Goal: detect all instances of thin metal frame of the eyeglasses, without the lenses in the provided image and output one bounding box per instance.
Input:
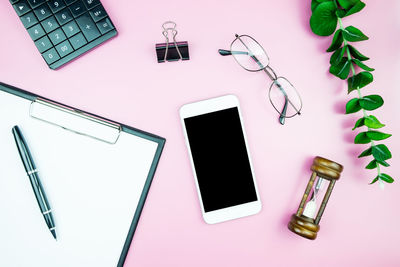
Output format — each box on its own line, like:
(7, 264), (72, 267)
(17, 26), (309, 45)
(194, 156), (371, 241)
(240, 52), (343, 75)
(218, 34), (303, 125)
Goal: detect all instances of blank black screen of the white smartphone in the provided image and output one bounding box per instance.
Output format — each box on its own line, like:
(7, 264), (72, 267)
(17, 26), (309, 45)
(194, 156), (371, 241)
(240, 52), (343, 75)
(184, 107), (257, 212)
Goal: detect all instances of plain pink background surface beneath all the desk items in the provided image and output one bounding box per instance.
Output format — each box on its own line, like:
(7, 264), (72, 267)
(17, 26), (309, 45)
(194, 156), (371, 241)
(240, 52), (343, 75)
(0, 0), (400, 267)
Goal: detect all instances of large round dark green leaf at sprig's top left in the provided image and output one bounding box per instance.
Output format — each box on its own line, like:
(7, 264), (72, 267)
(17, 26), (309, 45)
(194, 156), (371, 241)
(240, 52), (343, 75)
(310, 2), (338, 36)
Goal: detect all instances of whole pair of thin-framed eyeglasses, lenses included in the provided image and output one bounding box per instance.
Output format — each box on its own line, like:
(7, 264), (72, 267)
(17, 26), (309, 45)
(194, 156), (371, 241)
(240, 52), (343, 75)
(218, 34), (303, 125)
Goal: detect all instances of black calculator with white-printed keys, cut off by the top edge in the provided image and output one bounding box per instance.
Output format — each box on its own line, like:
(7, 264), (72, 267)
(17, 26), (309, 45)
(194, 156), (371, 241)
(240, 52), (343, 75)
(10, 0), (117, 69)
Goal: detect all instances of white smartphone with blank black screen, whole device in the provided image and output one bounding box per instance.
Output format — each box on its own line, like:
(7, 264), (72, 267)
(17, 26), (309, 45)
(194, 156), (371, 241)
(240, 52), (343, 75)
(180, 95), (261, 224)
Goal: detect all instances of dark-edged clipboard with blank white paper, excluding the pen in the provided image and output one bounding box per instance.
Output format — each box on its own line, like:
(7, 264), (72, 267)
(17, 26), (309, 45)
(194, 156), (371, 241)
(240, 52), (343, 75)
(0, 82), (165, 267)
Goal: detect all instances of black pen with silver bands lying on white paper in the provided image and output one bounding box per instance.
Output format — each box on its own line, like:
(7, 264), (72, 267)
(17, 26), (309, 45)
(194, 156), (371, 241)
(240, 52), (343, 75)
(12, 126), (57, 240)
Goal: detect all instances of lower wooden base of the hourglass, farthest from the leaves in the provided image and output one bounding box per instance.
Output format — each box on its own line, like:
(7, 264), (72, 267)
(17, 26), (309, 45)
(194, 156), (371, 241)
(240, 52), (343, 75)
(288, 214), (319, 240)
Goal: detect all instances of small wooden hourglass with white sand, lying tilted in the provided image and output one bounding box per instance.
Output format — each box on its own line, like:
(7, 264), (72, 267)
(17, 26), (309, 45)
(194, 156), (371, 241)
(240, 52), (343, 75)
(288, 157), (343, 240)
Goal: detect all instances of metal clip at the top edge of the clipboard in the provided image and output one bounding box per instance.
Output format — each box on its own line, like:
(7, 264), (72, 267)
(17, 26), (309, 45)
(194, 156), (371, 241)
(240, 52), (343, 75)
(29, 97), (122, 144)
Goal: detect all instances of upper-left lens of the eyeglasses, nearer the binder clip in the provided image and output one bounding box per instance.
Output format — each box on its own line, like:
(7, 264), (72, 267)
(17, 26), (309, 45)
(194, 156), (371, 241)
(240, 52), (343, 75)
(231, 35), (269, 71)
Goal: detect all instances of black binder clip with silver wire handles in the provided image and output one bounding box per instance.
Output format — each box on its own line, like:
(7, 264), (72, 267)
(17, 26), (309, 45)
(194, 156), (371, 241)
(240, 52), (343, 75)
(156, 21), (189, 63)
